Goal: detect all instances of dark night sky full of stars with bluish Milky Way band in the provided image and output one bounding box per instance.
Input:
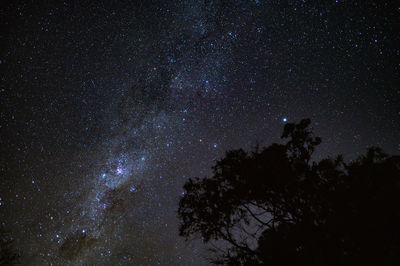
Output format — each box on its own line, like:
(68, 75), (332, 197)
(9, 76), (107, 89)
(0, 0), (400, 265)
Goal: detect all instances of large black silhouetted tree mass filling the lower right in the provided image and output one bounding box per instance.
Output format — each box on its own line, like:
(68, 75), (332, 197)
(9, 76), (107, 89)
(178, 119), (400, 265)
